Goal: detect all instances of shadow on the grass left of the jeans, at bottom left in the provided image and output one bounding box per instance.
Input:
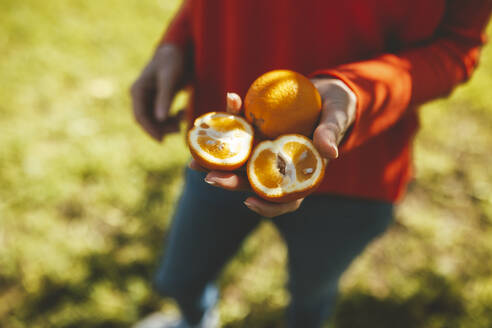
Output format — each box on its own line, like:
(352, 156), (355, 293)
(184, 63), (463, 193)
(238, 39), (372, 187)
(9, 166), (182, 328)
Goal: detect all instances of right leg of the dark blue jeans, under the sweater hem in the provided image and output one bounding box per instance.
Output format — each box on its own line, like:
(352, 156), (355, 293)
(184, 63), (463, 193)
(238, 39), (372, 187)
(273, 195), (393, 328)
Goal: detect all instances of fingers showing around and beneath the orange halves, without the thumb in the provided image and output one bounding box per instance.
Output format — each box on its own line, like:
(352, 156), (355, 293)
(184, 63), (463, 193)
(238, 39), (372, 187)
(190, 93), (303, 218)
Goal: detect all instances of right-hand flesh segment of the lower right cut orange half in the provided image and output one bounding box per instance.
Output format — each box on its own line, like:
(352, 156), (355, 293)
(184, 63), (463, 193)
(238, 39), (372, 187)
(283, 142), (317, 182)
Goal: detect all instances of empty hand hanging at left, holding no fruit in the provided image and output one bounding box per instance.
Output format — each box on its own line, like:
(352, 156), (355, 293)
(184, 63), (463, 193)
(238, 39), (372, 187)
(130, 44), (184, 141)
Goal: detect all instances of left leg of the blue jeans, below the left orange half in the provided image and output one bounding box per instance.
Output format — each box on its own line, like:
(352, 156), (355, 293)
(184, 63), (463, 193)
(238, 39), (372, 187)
(155, 169), (261, 324)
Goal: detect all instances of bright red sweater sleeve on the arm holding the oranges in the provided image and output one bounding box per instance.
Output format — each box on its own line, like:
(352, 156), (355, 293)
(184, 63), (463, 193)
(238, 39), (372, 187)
(313, 0), (492, 151)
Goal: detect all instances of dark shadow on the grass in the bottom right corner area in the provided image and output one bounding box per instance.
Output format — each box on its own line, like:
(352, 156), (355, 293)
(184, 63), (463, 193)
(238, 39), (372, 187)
(334, 271), (466, 328)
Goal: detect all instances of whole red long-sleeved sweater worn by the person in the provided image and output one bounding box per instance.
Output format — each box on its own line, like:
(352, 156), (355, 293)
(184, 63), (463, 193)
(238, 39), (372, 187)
(162, 0), (492, 201)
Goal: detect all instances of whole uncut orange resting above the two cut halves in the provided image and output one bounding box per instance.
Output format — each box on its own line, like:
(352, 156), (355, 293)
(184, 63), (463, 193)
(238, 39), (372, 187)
(244, 70), (321, 139)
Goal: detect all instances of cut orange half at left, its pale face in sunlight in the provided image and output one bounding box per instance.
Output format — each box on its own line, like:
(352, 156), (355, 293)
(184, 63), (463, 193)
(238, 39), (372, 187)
(187, 112), (254, 171)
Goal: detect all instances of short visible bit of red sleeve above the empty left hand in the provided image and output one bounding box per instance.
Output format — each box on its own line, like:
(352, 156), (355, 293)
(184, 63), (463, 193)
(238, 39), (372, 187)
(159, 0), (192, 50)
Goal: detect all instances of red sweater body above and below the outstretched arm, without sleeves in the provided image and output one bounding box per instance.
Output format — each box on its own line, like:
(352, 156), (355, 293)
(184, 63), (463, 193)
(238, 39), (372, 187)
(183, 0), (448, 201)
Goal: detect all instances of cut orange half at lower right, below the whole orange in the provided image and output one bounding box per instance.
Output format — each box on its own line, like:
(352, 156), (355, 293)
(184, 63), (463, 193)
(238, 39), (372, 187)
(247, 134), (325, 203)
